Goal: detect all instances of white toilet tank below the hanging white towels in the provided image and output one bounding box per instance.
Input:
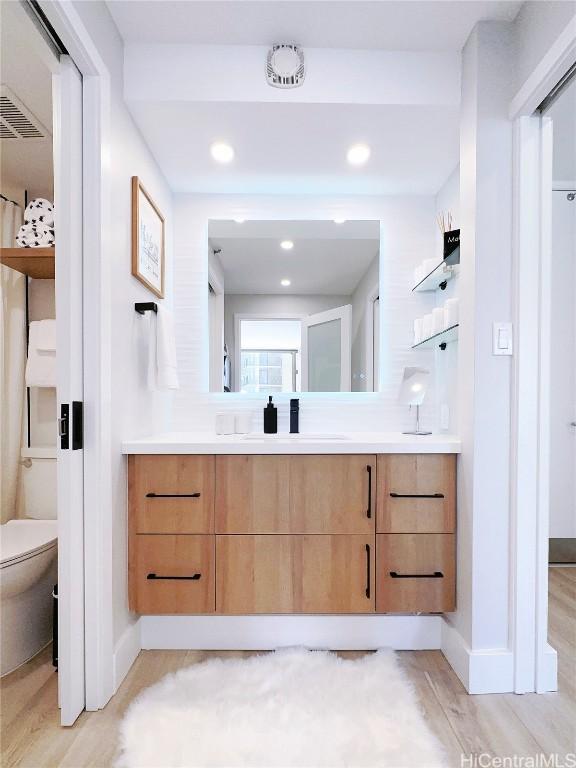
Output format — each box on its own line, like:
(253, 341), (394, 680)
(18, 448), (58, 520)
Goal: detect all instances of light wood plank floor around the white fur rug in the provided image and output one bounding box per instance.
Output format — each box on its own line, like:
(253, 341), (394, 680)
(1, 568), (576, 768)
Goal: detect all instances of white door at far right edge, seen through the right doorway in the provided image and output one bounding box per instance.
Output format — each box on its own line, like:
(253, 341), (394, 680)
(549, 191), (576, 539)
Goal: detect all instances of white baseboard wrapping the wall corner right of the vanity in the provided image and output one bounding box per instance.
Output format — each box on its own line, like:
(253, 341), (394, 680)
(441, 619), (514, 693)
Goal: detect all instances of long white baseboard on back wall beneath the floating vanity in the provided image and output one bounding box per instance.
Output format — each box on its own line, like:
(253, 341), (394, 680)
(140, 615), (442, 651)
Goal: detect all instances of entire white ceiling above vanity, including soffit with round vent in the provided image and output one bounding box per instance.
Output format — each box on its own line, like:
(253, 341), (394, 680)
(108, 0), (522, 195)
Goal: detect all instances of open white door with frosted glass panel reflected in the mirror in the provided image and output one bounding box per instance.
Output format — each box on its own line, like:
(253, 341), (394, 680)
(302, 304), (352, 392)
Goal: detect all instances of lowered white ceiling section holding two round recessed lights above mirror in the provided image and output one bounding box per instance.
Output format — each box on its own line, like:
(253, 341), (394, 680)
(131, 102), (459, 195)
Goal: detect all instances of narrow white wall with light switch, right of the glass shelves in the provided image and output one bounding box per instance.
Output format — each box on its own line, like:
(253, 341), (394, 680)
(445, 22), (514, 690)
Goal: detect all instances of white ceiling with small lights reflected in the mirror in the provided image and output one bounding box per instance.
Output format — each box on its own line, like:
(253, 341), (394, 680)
(209, 221), (380, 296)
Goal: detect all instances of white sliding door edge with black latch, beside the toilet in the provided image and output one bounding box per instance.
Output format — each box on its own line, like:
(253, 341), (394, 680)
(54, 56), (85, 725)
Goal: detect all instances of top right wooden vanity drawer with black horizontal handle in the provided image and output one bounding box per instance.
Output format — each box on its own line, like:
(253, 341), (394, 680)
(376, 454), (456, 533)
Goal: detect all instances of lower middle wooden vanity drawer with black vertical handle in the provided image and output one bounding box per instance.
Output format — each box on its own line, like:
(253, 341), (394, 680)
(216, 535), (375, 614)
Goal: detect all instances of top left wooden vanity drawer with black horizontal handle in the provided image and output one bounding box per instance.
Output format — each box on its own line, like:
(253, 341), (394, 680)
(128, 456), (214, 533)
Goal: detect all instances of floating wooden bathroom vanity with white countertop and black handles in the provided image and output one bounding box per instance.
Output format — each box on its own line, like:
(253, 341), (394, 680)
(124, 435), (459, 615)
